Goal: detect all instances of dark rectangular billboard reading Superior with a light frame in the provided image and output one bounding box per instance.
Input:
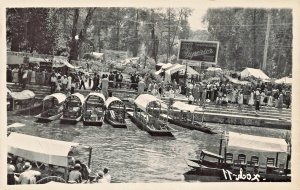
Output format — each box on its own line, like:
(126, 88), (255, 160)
(178, 40), (219, 64)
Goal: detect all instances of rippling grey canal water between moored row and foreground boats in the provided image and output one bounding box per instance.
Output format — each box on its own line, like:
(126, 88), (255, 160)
(7, 112), (287, 183)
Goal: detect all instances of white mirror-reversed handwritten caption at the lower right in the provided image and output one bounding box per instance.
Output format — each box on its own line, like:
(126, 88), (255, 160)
(222, 168), (260, 182)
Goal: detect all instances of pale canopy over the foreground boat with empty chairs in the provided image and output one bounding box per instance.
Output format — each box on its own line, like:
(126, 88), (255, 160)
(228, 132), (288, 152)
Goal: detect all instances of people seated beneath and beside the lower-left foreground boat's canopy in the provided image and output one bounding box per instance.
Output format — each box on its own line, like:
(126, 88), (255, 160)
(7, 155), (111, 185)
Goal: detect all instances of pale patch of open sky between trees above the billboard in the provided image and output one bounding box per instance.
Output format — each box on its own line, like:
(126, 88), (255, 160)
(189, 7), (207, 30)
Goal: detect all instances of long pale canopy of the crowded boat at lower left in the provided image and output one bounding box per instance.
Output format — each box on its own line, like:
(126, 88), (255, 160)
(7, 132), (79, 167)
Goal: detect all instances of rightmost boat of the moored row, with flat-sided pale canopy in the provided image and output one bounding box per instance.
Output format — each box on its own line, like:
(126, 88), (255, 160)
(168, 101), (216, 134)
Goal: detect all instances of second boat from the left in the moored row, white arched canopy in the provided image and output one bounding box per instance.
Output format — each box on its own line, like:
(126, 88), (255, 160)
(34, 93), (67, 122)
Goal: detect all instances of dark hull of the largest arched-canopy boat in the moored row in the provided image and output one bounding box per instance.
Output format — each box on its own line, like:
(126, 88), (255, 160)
(128, 111), (174, 137)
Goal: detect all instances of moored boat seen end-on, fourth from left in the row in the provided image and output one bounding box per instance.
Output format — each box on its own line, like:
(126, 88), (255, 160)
(83, 92), (105, 126)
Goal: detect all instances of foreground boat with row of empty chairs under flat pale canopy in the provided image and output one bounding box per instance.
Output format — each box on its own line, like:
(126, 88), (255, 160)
(183, 132), (291, 182)
